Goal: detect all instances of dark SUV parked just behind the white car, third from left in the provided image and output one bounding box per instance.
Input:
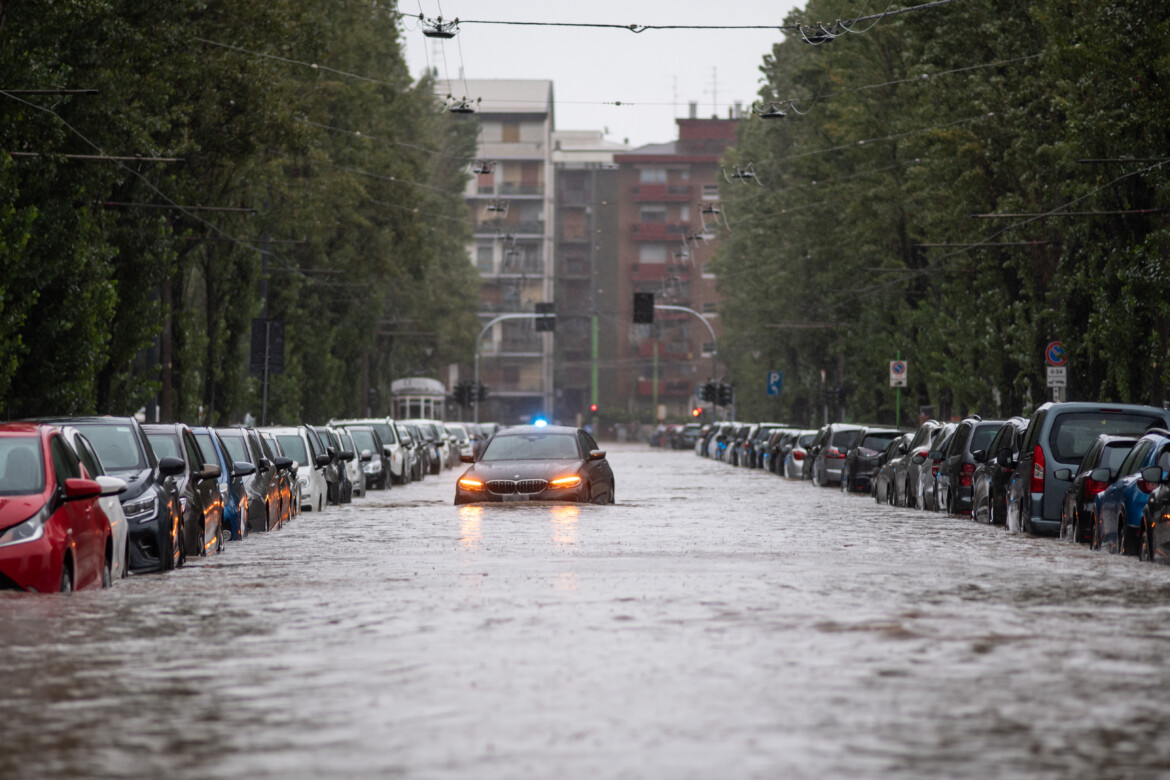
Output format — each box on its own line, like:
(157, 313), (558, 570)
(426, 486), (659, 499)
(49, 416), (186, 574)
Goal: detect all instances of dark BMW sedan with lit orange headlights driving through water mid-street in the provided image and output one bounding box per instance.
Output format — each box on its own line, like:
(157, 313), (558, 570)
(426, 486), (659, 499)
(455, 426), (614, 504)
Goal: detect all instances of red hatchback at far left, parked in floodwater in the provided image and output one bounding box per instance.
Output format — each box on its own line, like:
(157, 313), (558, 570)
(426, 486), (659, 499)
(0, 422), (113, 593)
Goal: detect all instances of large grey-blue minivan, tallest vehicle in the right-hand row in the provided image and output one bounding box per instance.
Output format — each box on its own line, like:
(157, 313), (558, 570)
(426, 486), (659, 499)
(1000, 401), (1170, 534)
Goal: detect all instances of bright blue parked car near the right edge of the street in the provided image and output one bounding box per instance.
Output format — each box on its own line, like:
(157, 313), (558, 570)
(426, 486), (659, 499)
(1089, 429), (1170, 555)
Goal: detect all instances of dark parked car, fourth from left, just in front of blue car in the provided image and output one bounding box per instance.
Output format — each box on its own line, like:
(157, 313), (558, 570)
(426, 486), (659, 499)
(143, 422), (223, 558)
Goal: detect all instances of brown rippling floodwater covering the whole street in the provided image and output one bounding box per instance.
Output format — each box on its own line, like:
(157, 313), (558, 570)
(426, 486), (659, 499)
(0, 446), (1170, 779)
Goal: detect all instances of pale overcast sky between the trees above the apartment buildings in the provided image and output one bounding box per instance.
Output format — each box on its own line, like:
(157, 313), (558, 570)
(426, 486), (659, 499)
(399, 0), (803, 146)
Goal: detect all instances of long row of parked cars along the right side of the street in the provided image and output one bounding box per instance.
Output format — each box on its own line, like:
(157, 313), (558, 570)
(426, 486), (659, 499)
(694, 401), (1170, 561)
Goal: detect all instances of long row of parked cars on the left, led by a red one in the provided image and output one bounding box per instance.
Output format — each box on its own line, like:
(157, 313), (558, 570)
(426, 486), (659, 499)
(0, 416), (494, 593)
